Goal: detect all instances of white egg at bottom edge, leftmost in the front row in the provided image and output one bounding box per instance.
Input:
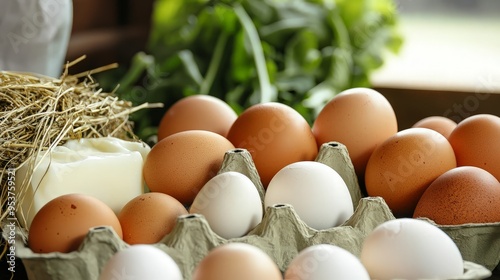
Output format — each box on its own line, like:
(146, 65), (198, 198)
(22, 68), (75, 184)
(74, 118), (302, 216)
(99, 244), (183, 280)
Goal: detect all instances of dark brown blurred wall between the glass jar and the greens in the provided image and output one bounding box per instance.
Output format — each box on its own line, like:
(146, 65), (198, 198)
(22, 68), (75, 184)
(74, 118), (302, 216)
(66, 0), (154, 73)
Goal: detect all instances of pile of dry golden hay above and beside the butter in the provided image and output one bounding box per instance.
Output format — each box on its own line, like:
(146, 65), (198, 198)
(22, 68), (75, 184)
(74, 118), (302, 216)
(0, 63), (162, 256)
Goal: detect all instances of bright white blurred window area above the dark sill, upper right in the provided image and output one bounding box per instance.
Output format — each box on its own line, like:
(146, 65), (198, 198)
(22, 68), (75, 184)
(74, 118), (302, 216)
(373, 0), (500, 92)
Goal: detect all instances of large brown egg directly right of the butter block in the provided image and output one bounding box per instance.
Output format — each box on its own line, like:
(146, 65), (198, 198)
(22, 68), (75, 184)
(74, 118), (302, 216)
(143, 130), (234, 205)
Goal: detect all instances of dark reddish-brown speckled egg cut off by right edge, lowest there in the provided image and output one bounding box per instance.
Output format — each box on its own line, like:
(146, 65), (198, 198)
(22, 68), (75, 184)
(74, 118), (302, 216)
(413, 166), (500, 225)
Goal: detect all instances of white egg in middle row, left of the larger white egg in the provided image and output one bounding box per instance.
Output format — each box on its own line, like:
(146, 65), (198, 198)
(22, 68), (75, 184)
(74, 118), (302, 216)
(189, 171), (263, 239)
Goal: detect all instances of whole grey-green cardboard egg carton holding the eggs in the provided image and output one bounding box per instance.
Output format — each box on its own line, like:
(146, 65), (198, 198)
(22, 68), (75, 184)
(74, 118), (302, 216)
(4, 142), (500, 280)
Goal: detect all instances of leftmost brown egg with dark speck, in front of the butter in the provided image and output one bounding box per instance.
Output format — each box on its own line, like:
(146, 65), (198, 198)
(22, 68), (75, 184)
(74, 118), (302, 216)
(28, 194), (122, 253)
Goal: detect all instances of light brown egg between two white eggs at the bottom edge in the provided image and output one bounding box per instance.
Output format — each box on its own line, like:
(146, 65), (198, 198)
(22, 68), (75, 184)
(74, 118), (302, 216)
(192, 243), (283, 280)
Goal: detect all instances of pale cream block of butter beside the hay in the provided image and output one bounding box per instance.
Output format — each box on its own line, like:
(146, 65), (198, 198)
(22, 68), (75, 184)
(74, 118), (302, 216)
(16, 137), (151, 228)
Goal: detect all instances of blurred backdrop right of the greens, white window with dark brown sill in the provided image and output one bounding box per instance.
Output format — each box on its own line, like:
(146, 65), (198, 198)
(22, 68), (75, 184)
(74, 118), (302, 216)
(372, 0), (500, 130)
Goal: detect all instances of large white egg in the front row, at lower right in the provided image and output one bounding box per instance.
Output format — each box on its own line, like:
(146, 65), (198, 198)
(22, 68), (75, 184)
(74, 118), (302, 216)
(361, 218), (464, 280)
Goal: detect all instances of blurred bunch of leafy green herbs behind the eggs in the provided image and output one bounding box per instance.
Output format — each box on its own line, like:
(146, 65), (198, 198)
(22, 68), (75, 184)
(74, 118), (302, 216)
(97, 0), (402, 138)
